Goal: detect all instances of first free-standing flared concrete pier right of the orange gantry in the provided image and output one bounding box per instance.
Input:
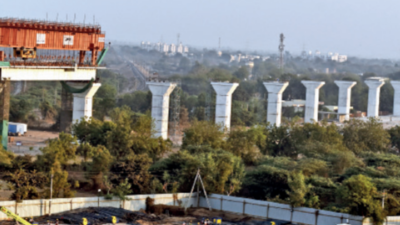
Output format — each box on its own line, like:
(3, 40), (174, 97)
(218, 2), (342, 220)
(146, 82), (176, 139)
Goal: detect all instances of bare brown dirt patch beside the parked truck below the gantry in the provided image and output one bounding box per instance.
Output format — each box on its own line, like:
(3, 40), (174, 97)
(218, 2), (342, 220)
(8, 130), (59, 155)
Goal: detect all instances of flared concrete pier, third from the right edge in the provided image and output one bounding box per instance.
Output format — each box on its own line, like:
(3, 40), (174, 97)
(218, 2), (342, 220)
(335, 80), (357, 120)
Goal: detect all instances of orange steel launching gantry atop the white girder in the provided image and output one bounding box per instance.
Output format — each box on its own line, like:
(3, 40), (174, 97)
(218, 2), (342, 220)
(0, 18), (107, 66)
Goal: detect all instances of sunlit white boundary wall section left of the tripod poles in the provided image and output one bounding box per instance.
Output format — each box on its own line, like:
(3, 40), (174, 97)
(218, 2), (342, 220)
(0, 193), (197, 220)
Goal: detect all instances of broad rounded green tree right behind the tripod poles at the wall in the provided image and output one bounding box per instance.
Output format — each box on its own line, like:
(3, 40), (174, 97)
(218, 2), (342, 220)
(150, 147), (245, 194)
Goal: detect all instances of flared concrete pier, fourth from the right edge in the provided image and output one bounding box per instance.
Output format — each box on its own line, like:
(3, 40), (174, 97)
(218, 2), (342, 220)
(301, 80), (325, 123)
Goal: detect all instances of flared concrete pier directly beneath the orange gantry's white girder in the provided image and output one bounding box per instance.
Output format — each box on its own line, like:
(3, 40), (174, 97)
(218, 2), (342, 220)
(71, 83), (101, 123)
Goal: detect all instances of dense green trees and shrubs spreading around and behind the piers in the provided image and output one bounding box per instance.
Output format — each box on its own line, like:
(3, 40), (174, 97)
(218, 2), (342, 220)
(6, 46), (400, 223)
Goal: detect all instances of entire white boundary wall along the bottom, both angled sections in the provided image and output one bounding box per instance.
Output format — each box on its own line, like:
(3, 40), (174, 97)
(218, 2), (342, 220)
(0, 193), (400, 225)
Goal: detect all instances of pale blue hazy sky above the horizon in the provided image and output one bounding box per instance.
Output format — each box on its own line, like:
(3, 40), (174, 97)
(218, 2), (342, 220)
(0, 0), (400, 58)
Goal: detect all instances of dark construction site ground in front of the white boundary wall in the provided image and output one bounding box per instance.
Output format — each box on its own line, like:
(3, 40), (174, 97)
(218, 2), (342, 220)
(0, 207), (282, 225)
